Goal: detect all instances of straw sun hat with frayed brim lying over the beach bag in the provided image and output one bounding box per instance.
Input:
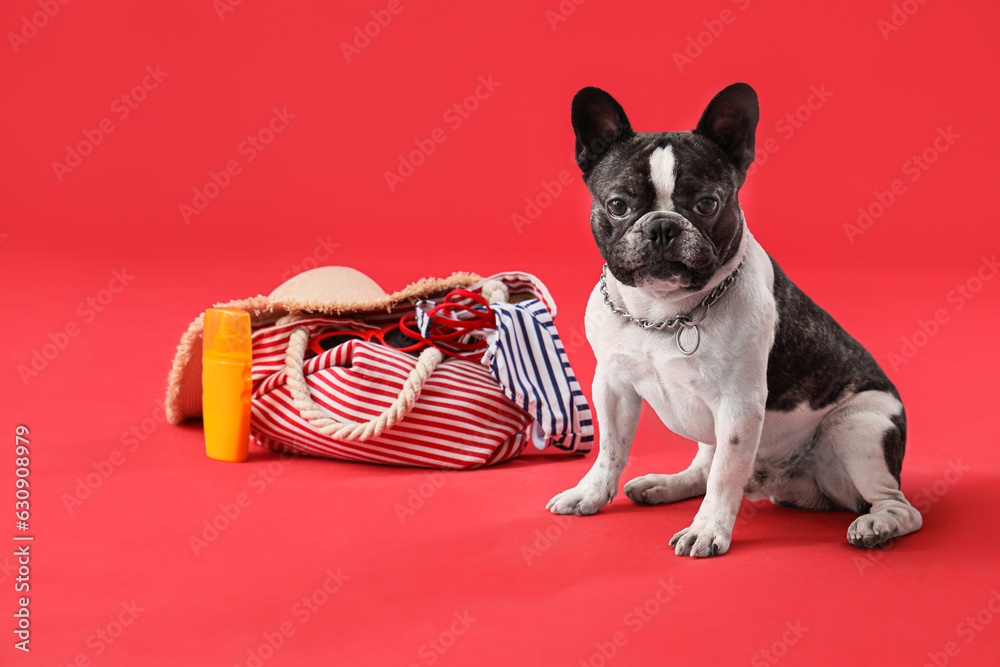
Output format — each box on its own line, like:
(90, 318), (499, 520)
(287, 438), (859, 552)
(166, 266), (482, 424)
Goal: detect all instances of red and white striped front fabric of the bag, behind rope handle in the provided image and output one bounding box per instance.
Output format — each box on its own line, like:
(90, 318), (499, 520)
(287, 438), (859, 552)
(251, 314), (532, 469)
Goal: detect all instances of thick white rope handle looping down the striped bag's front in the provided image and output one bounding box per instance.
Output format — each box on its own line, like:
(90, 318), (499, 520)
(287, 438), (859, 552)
(285, 327), (443, 442)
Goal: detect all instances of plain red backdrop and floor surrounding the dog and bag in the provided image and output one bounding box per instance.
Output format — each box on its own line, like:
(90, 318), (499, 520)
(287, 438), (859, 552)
(0, 0), (1000, 667)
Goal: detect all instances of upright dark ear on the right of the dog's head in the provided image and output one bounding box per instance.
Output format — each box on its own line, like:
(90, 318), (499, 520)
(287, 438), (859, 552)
(695, 83), (760, 174)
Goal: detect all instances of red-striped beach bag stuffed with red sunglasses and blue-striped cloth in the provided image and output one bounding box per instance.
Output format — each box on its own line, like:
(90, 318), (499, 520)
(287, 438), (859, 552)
(160, 267), (593, 469)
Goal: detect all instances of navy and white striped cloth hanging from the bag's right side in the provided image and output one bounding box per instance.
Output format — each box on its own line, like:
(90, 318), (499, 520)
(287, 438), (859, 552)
(416, 299), (594, 453)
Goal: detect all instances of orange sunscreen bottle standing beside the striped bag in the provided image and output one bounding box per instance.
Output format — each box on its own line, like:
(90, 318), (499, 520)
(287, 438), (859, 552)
(201, 308), (251, 462)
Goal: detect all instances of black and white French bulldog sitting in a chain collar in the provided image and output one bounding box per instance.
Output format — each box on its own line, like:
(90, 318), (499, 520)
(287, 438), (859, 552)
(547, 83), (922, 557)
